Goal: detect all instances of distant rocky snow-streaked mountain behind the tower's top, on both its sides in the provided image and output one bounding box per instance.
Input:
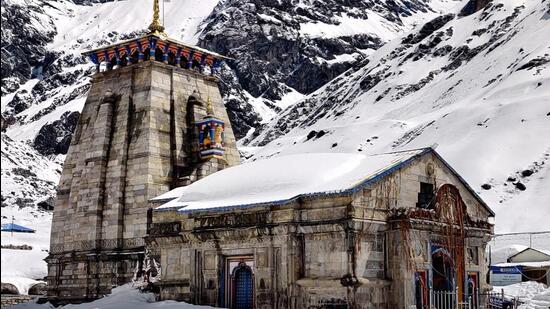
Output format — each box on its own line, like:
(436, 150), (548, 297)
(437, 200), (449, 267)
(2, 0), (466, 148)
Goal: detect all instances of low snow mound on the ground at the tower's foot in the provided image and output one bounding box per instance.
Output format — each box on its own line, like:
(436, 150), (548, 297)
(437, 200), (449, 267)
(10, 284), (213, 309)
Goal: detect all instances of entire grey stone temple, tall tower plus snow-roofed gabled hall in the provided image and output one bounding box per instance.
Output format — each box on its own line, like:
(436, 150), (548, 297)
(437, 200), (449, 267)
(46, 0), (494, 309)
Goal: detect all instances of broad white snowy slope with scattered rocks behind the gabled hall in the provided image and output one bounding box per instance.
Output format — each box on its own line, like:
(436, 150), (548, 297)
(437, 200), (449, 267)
(247, 0), (550, 231)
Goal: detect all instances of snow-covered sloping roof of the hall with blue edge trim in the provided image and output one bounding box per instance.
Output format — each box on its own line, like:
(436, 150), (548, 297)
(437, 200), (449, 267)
(152, 148), (496, 213)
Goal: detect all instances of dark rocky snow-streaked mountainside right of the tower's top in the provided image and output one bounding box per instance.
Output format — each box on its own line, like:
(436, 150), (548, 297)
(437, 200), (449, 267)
(199, 0), (459, 132)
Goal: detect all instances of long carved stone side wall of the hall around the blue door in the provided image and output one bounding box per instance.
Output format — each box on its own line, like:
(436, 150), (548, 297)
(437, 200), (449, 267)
(150, 196), (389, 308)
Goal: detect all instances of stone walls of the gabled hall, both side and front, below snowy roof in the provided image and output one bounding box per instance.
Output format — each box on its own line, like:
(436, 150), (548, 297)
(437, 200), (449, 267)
(148, 154), (491, 308)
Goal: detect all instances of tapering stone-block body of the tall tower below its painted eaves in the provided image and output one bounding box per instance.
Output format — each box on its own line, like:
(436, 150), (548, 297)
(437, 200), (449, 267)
(46, 61), (244, 302)
